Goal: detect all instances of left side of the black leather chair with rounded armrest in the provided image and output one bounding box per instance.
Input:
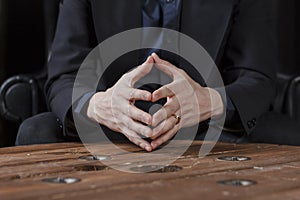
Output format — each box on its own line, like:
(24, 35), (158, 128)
(0, 0), (60, 124)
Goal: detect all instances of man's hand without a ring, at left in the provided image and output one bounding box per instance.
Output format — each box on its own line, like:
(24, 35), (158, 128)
(87, 57), (154, 151)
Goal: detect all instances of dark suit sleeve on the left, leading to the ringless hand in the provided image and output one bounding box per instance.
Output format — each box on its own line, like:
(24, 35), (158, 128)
(45, 0), (97, 136)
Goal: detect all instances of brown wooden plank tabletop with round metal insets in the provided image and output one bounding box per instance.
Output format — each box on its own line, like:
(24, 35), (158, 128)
(0, 142), (300, 200)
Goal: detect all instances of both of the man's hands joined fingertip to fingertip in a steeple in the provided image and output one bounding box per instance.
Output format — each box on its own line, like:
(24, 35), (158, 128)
(87, 54), (224, 151)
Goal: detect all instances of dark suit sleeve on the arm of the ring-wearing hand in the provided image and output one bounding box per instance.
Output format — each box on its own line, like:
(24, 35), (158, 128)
(223, 0), (278, 134)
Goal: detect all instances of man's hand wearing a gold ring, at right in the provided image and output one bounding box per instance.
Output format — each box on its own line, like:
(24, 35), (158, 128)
(151, 54), (224, 149)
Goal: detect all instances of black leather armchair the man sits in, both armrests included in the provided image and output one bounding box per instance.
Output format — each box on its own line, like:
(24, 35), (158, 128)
(0, 0), (300, 143)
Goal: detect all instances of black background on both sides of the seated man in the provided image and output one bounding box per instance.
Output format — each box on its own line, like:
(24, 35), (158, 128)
(0, 0), (300, 147)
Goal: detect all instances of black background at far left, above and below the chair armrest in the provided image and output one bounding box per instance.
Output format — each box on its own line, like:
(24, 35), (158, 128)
(0, 0), (46, 146)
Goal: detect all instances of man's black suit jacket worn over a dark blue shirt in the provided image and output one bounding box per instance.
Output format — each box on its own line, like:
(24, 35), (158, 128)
(46, 0), (278, 133)
